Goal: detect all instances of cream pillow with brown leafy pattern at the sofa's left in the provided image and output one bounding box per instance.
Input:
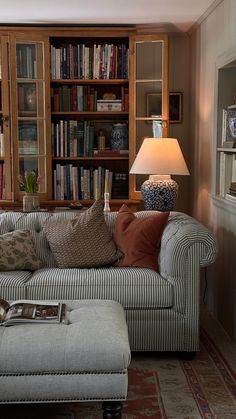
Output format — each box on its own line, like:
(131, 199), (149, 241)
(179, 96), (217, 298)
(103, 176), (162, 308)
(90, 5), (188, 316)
(0, 230), (42, 271)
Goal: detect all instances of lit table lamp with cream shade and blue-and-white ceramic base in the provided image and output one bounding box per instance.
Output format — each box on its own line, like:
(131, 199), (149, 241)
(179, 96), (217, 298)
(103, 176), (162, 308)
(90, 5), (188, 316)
(130, 138), (190, 211)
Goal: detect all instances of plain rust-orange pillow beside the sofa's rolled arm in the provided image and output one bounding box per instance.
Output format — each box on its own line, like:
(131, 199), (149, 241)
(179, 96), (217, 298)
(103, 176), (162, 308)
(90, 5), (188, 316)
(114, 204), (169, 271)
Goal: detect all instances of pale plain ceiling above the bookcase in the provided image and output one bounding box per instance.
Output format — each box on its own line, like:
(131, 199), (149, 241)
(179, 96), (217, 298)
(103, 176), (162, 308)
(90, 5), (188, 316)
(0, 0), (219, 32)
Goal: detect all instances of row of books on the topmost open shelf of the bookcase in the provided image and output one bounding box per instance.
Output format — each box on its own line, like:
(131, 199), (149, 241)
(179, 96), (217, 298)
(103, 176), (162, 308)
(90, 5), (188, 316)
(51, 43), (129, 80)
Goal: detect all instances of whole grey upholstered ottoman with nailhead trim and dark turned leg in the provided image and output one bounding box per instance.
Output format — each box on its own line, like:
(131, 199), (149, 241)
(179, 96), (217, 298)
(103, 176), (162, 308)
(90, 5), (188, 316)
(0, 300), (130, 418)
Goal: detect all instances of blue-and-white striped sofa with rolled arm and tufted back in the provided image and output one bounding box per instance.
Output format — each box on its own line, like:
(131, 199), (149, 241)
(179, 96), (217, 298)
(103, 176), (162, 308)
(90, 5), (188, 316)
(0, 211), (217, 352)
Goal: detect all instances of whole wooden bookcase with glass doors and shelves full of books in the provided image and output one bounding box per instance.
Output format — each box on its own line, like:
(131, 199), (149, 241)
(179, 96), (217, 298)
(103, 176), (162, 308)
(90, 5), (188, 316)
(0, 27), (168, 209)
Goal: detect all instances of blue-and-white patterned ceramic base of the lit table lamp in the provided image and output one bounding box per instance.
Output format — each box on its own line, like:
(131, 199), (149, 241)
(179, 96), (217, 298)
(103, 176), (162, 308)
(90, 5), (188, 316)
(141, 176), (179, 211)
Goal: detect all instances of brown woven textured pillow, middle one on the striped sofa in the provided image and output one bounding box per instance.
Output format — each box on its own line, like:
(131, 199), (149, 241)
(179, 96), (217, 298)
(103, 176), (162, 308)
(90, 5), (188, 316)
(43, 201), (121, 268)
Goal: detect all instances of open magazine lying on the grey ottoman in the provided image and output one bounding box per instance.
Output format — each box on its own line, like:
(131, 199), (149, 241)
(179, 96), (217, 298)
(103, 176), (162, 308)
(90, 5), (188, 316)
(0, 299), (66, 326)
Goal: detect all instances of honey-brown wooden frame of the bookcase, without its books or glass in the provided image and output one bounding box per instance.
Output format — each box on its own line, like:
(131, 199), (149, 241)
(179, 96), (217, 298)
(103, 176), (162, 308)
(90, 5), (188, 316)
(0, 27), (169, 208)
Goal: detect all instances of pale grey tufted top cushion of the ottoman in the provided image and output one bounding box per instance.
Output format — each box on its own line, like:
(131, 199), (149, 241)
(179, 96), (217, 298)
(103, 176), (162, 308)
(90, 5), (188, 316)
(0, 300), (130, 376)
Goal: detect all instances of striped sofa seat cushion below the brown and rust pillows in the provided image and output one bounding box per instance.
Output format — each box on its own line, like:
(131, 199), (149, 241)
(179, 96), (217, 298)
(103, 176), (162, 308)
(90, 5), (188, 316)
(27, 267), (173, 309)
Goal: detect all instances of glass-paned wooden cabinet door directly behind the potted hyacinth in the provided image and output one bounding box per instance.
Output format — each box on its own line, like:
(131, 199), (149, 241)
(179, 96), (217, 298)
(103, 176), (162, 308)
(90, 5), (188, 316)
(9, 37), (50, 199)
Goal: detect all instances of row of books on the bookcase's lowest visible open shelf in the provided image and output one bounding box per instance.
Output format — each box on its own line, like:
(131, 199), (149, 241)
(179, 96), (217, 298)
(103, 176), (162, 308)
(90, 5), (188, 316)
(53, 164), (128, 200)
